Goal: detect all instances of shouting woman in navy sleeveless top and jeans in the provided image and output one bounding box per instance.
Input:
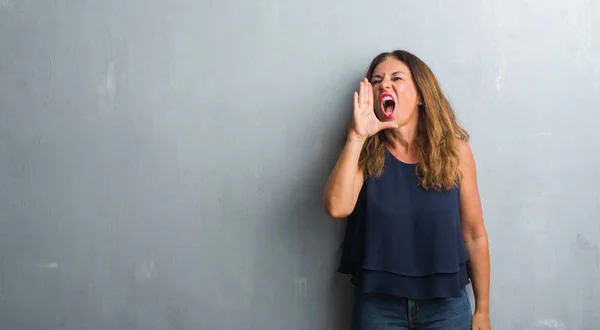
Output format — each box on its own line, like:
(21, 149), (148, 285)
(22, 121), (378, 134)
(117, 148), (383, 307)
(324, 51), (491, 330)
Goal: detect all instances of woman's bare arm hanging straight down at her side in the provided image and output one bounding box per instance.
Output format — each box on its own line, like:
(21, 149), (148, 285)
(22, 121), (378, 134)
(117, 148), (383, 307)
(459, 141), (490, 318)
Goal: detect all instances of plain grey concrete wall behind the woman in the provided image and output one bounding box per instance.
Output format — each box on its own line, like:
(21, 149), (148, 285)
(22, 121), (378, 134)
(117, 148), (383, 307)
(0, 0), (600, 330)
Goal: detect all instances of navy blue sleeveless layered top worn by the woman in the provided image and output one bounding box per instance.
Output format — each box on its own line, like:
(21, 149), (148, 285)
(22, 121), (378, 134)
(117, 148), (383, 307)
(338, 150), (469, 299)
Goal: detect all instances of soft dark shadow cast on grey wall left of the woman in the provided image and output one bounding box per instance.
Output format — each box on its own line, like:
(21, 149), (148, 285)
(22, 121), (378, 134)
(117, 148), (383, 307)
(287, 77), (362, 330)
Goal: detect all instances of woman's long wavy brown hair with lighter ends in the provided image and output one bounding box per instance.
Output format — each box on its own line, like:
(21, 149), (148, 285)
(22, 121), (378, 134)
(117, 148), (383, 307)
(359, 50), (469, 190)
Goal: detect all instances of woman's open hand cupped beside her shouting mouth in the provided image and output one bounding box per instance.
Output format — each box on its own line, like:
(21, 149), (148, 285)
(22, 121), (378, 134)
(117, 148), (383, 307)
(351, 78), (398, 141)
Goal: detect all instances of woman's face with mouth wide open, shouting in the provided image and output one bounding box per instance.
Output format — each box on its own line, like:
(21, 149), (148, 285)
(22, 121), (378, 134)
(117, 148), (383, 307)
(371, 57), (420, 126)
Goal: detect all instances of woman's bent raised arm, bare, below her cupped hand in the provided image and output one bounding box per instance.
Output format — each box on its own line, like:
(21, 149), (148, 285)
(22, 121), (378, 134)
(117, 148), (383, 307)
(323, 133), (364, 219)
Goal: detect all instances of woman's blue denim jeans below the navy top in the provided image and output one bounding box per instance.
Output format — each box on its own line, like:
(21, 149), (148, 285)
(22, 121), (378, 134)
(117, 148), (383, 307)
(351, 288), (472, 330)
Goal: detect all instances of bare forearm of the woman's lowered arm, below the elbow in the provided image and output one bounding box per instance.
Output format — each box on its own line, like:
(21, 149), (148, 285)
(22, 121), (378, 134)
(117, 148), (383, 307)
(466, 235), (490, 313)
